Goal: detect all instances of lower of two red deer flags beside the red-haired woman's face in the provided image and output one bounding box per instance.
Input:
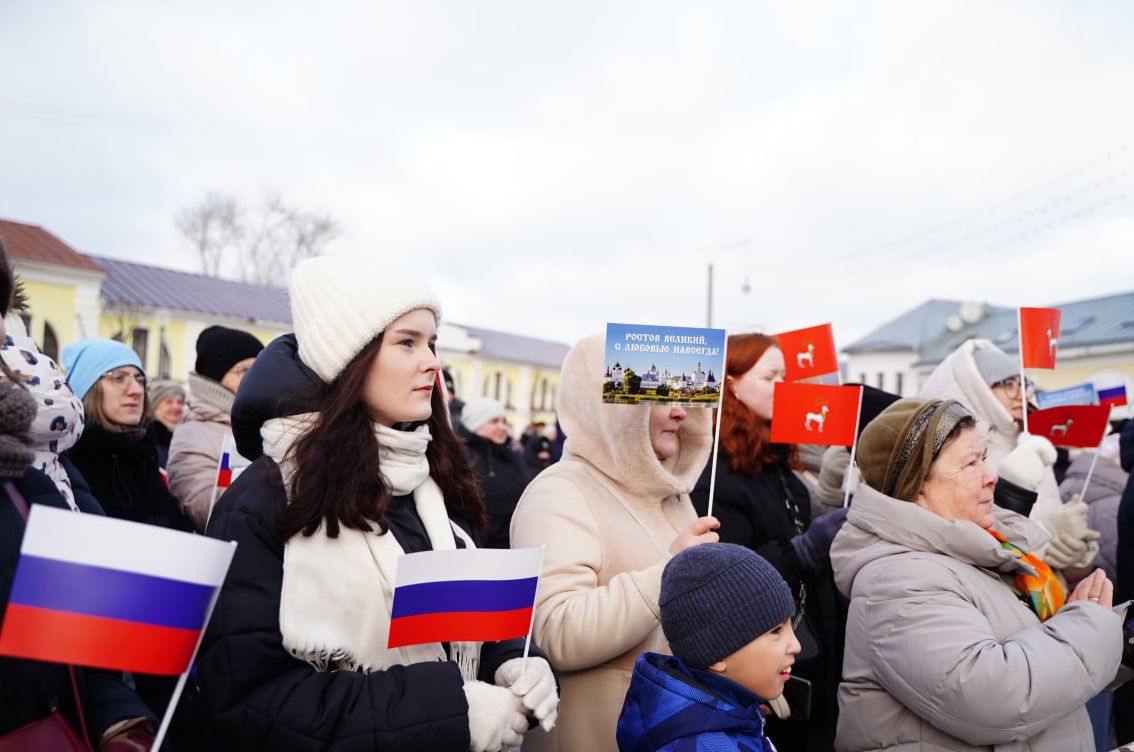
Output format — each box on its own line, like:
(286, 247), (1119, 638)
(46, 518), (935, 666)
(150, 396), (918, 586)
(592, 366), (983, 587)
(772, 381), (862, 447)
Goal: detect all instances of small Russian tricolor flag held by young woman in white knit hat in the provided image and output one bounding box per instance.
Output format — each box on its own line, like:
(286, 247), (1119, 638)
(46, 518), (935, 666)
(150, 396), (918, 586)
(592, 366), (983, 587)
(387, 548), (543, 648)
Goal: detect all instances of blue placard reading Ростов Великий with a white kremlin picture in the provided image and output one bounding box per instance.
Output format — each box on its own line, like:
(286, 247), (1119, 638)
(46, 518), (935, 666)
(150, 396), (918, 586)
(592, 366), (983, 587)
(602, 323), (725, 407)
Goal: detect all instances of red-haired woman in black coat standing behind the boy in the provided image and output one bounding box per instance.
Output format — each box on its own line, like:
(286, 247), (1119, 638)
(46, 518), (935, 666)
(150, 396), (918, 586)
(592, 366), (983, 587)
(693, 335), (846, 751)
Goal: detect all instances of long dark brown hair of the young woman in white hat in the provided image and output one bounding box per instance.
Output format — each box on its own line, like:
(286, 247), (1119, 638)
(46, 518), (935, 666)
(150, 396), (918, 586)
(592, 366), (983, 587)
(280, 335), (488, 540)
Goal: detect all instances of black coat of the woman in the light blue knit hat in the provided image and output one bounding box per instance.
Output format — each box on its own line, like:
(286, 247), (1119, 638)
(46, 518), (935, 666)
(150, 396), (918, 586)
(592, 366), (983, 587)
(66, 423), (192, 532)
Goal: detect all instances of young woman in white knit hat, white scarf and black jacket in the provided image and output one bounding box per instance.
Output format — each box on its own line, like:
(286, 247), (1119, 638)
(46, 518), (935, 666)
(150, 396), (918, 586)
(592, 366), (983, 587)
(197, 256), (558, 752)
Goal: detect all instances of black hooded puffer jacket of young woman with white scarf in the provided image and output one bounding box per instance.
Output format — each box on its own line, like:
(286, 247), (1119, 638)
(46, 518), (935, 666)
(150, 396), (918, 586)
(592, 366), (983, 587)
(197, 336), (542, 752)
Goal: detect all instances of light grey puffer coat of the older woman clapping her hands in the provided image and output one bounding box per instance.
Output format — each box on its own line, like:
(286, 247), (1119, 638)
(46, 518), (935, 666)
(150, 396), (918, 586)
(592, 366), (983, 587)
(831, 485), (1126, 752)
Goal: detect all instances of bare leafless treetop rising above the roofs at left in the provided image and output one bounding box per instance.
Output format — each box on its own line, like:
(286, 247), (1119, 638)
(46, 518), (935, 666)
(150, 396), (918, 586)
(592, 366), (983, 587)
(177, 192), (341, 285)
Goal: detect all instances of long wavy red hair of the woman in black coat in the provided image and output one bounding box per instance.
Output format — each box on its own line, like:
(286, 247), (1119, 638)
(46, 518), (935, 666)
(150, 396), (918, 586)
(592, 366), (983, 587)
(719, 335), (803, 475)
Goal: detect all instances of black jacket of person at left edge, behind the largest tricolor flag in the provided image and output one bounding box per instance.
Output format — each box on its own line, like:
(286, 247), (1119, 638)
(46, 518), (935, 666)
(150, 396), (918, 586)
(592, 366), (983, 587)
(0, 463), (154, 746)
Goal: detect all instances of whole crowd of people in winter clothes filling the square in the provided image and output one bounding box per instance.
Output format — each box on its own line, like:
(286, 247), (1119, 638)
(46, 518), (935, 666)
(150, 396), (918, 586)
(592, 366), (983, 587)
(0, 237), (1134, 752)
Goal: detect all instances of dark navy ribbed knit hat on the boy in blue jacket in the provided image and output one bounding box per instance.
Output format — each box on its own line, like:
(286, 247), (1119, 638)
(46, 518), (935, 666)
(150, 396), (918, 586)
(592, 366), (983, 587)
(658, 543), (795, 668)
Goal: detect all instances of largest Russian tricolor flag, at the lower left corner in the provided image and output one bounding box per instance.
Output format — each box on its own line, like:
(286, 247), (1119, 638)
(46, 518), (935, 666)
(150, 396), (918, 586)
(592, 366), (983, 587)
(0, 505), (236, 675)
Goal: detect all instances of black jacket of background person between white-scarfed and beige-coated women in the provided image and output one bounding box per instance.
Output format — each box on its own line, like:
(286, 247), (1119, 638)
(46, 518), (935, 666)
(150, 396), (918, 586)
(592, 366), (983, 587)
(460, 429), (535, 548)
